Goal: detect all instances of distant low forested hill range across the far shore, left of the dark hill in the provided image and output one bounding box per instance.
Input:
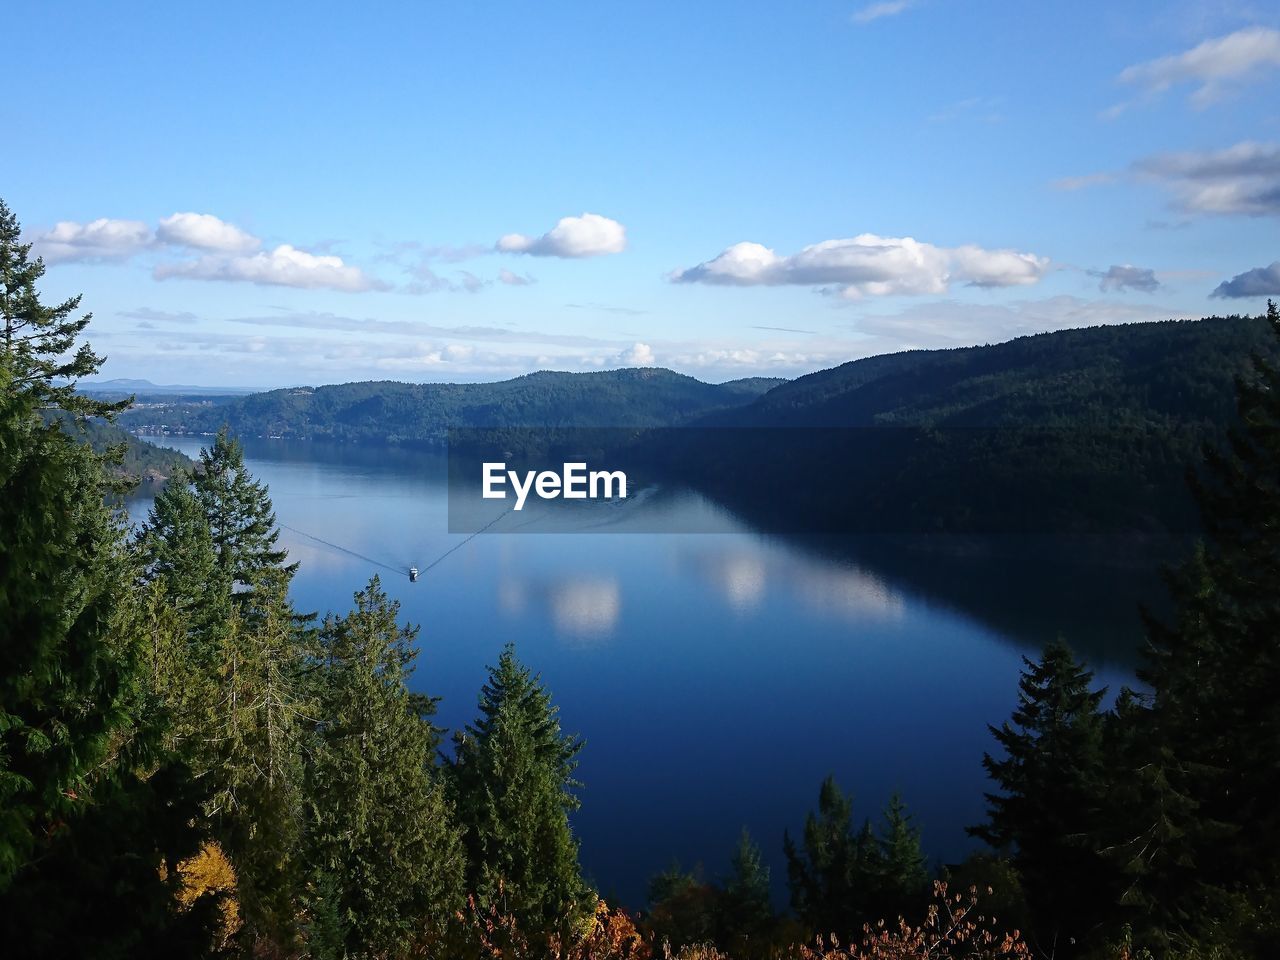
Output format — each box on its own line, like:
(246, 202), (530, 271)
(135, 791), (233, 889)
(120, 367), (783, 444)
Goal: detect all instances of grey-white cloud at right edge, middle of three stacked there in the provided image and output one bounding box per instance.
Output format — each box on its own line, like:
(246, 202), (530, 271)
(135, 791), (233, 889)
(1135, 142), (1280, 216)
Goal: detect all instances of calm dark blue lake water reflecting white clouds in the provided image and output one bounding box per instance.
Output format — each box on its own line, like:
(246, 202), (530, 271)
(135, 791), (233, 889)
(137, 440), (1149, 906)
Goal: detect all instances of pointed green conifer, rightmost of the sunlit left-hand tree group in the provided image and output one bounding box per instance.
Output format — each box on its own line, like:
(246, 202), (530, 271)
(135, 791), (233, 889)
(452, 645), (593, 934)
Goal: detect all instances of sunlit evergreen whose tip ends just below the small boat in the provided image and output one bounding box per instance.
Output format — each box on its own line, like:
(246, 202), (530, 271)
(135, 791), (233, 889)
(305, 577), (463, 956)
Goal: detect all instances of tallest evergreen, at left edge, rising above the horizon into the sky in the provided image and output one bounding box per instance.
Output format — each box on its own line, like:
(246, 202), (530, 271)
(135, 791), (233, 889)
(0, 202), (221, 957)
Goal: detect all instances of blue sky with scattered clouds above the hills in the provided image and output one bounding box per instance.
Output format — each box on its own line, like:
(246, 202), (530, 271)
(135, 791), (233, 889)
(0, 0), (1280, 388)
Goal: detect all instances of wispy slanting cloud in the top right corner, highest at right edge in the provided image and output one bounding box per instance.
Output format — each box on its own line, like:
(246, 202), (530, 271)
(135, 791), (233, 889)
(1108, 27), (1280, 115)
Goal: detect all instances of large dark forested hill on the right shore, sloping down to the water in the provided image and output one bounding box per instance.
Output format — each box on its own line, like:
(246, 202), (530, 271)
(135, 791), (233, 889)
(650, 316), (1277, 534)
